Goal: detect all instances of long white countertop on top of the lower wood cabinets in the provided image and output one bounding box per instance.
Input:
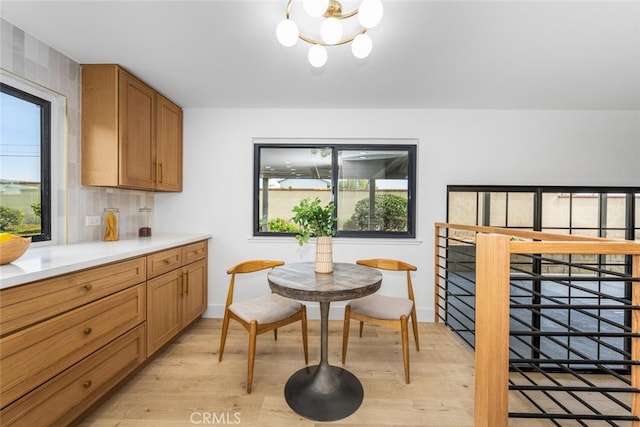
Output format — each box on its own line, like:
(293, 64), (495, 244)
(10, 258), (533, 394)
(0, 234), (211, 289)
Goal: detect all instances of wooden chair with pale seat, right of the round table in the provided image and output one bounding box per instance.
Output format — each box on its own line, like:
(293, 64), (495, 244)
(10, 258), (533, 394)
(342, 258), (420, 384)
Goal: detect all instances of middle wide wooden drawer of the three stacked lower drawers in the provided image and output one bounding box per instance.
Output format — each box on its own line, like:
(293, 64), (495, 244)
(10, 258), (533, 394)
(0, 283), (146, 407)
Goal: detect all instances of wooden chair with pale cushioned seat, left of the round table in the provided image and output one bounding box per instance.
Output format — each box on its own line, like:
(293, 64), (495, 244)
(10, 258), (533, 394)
(218, 260), (309, 393)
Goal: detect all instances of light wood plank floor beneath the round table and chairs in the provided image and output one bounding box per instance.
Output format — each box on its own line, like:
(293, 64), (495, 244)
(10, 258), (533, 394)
(81, 319), (534, 427)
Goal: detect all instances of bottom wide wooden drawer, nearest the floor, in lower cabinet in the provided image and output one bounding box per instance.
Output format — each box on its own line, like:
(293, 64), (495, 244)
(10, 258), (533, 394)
(0, 324), (145, 426)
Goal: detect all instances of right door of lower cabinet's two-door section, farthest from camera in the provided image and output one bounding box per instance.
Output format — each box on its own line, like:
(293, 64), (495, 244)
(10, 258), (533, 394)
(182, 260), (207, 326)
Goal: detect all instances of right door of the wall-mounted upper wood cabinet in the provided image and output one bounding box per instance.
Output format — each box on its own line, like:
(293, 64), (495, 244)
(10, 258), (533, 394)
(156, 95), (182, 191)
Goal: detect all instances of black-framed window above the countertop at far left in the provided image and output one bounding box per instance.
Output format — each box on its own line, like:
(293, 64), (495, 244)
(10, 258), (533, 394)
(0, 83), (51, 241)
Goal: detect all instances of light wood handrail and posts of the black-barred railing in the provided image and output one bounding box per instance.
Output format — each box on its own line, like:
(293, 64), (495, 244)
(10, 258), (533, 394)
(434, 222), (640, 427)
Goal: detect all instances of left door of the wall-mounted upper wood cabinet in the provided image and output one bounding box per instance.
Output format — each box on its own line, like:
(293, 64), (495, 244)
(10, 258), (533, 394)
(119, 70), (157, 189)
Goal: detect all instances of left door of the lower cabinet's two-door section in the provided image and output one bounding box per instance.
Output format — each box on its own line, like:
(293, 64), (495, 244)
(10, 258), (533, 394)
(147, 269), (182, 356)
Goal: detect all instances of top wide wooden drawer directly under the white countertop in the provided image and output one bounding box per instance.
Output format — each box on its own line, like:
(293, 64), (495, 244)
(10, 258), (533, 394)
(0, 257), (146, 335)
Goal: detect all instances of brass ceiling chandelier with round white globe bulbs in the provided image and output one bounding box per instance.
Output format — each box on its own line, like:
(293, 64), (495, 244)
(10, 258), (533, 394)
(276, 0), (383, 67)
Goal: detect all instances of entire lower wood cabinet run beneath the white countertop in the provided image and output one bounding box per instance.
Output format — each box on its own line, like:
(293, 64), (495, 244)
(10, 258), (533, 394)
(0, 240), (208, 426)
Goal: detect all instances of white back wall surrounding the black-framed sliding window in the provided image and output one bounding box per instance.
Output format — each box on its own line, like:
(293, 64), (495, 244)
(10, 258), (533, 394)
(155, 109), (640, 321)
